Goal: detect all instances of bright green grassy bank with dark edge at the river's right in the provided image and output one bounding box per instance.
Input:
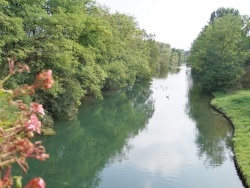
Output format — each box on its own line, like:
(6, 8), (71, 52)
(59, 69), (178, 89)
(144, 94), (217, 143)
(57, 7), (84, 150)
(211, 90), (250, 187)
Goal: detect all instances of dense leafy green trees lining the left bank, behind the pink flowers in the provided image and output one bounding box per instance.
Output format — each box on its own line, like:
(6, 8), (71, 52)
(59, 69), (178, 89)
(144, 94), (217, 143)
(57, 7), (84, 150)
(0, 0), (162, 118)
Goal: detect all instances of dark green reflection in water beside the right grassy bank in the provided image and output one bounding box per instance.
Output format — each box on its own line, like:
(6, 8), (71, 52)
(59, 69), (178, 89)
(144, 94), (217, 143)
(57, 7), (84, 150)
(186, 75), (233, 168)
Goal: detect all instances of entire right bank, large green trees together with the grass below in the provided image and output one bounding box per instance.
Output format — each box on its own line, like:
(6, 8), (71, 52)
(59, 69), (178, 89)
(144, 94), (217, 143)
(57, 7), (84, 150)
(188, 8), (250, 187)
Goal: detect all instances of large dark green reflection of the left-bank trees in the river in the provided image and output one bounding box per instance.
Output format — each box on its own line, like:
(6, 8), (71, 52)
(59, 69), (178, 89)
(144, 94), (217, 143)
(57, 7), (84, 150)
(21, 83), (154, 188)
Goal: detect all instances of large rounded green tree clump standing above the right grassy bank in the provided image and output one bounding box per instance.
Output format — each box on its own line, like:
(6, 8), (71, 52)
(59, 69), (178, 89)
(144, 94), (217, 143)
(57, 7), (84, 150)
(188, 8), (249, 91)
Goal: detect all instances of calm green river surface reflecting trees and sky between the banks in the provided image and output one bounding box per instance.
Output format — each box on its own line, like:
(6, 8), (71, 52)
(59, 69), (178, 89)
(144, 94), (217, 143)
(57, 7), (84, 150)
(25, 66), (243, 188)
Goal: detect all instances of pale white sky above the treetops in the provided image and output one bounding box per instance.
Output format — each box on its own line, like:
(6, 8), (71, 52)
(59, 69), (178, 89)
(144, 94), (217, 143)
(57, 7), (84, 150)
(96, 0), (250, 50)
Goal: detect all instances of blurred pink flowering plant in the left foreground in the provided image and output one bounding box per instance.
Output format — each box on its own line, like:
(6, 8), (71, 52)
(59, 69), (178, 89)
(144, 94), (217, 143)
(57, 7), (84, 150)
(0, 58), (54, 188)
